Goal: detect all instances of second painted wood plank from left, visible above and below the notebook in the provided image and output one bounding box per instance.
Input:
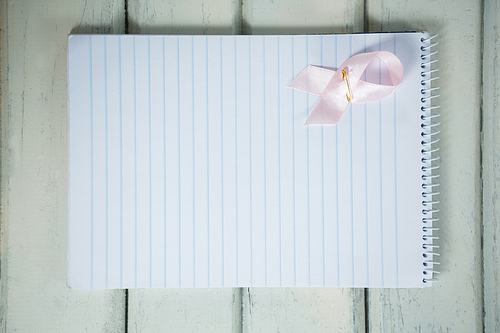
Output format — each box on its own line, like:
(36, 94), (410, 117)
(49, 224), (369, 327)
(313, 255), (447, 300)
(128, 0), (241, 332)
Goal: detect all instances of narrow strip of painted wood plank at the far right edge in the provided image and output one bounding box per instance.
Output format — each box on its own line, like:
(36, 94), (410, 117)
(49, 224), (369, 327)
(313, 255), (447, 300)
(482, 1), (500, 332)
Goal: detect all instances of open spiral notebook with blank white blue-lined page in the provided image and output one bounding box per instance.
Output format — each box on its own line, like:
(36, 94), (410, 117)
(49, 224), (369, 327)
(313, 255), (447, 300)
(68, 32), (439, 289)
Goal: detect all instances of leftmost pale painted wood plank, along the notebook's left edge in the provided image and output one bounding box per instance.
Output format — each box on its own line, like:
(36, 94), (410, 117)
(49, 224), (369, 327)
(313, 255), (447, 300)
(1, 0), (125, 332)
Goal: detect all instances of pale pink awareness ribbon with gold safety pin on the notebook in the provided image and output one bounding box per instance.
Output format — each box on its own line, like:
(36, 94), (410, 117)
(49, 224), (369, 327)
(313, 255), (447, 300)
(290, 51), (404, 125)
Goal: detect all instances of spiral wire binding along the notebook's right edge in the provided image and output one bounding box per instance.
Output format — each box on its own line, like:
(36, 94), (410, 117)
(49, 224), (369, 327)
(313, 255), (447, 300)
(420, 33), (441, 283)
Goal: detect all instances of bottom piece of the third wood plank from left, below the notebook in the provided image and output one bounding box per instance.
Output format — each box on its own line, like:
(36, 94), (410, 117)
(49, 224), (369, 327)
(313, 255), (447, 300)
(242, 288), (365, 333)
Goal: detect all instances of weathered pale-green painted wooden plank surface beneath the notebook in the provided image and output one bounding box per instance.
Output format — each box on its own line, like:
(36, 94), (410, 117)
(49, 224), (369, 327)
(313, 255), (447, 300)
(0, 0), (500, 332)
